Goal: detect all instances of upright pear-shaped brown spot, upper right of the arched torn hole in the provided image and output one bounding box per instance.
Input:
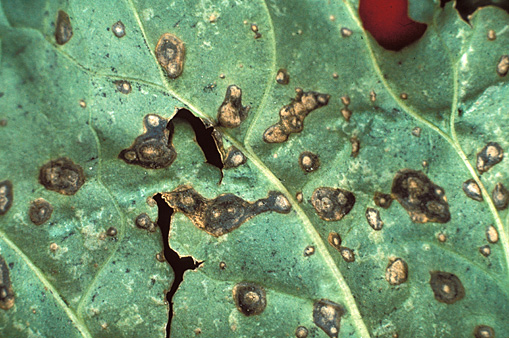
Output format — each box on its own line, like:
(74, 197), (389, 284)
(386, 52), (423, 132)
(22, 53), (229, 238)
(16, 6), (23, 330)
(217, 85), (250, 128)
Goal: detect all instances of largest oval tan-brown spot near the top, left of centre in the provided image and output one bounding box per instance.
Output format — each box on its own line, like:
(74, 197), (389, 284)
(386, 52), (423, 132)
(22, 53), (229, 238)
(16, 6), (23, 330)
(155, 33), (186, 79)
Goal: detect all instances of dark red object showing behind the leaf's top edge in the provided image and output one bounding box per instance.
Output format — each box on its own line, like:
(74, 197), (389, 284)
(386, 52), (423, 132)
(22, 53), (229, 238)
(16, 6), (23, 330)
(359, 0), (428, 51)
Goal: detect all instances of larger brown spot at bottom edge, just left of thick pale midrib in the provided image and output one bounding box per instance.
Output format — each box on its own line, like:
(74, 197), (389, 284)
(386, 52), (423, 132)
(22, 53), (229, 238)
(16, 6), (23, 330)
(313, 299), (345, 338)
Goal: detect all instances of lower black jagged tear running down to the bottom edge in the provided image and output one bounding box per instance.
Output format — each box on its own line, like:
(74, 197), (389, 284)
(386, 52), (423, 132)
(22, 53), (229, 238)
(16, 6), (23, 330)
(153, 194), (203, 337)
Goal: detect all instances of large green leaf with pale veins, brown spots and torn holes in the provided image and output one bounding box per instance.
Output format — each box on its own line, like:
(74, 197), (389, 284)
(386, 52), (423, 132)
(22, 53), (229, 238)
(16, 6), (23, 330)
(0, 0), (509, 338)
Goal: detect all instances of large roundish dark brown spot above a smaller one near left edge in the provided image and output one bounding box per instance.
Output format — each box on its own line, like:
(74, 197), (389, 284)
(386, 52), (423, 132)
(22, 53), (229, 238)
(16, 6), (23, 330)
(39, 157), (85, 195)
